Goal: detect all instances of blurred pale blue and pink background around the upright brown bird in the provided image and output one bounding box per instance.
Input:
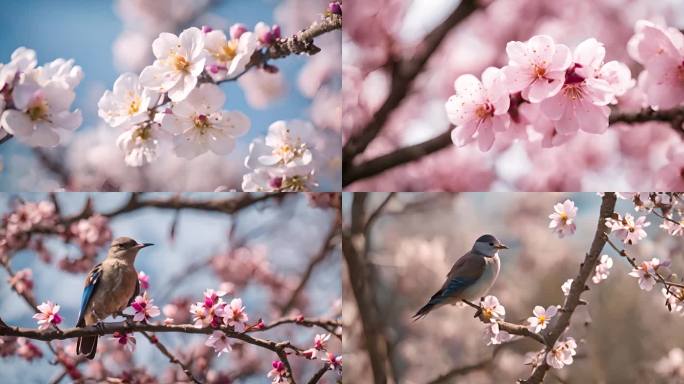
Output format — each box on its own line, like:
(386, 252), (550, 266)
(0, 193), (341, 383)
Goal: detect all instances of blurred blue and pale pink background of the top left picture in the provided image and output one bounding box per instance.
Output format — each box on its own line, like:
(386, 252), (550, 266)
(0, 0), (341, 191)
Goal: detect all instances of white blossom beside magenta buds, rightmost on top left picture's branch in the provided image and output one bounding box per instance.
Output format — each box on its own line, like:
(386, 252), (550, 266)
(204, 24), (257, 81)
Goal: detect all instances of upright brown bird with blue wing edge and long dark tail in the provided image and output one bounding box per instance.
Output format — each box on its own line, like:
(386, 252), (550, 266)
(76, 237), (153, 360)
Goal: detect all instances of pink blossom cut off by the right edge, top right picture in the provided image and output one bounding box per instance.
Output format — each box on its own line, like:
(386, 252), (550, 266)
(627, 20), (684, 109)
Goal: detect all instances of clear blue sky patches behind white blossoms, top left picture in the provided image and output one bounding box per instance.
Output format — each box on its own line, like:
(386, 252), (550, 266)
(0, 0), (329, 191)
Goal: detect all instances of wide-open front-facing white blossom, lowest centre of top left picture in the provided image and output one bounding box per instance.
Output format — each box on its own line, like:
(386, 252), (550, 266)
(162, 83), (250, 159)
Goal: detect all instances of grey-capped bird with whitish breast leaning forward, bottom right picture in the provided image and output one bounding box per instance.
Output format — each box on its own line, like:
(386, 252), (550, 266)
(413, 235), (508, 320)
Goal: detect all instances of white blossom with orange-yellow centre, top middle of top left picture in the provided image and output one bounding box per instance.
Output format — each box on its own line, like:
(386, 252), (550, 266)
(140, 27), (206, 102)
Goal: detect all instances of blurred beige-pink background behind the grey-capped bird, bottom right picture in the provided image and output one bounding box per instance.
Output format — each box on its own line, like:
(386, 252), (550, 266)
(343, 193), (684, 384)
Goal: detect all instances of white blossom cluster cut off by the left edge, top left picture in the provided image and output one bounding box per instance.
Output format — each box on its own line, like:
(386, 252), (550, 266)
(0, 47), (83, 147)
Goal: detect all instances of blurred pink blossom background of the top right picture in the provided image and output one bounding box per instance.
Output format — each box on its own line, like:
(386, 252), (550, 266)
(342, 0), (684, 192)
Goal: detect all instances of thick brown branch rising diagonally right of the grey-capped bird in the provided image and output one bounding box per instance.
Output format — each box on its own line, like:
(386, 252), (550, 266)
(519, 192), (617, 384)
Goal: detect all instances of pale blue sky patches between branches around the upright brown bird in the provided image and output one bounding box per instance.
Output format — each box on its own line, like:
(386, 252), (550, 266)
(0, 193), (342, 384)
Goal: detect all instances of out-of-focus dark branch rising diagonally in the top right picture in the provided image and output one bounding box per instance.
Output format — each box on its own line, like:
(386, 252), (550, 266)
(342, 0), (478, 169)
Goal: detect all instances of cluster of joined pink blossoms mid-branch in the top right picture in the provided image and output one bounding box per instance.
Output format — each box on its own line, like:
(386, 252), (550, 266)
(445, 35), (634, 151)
